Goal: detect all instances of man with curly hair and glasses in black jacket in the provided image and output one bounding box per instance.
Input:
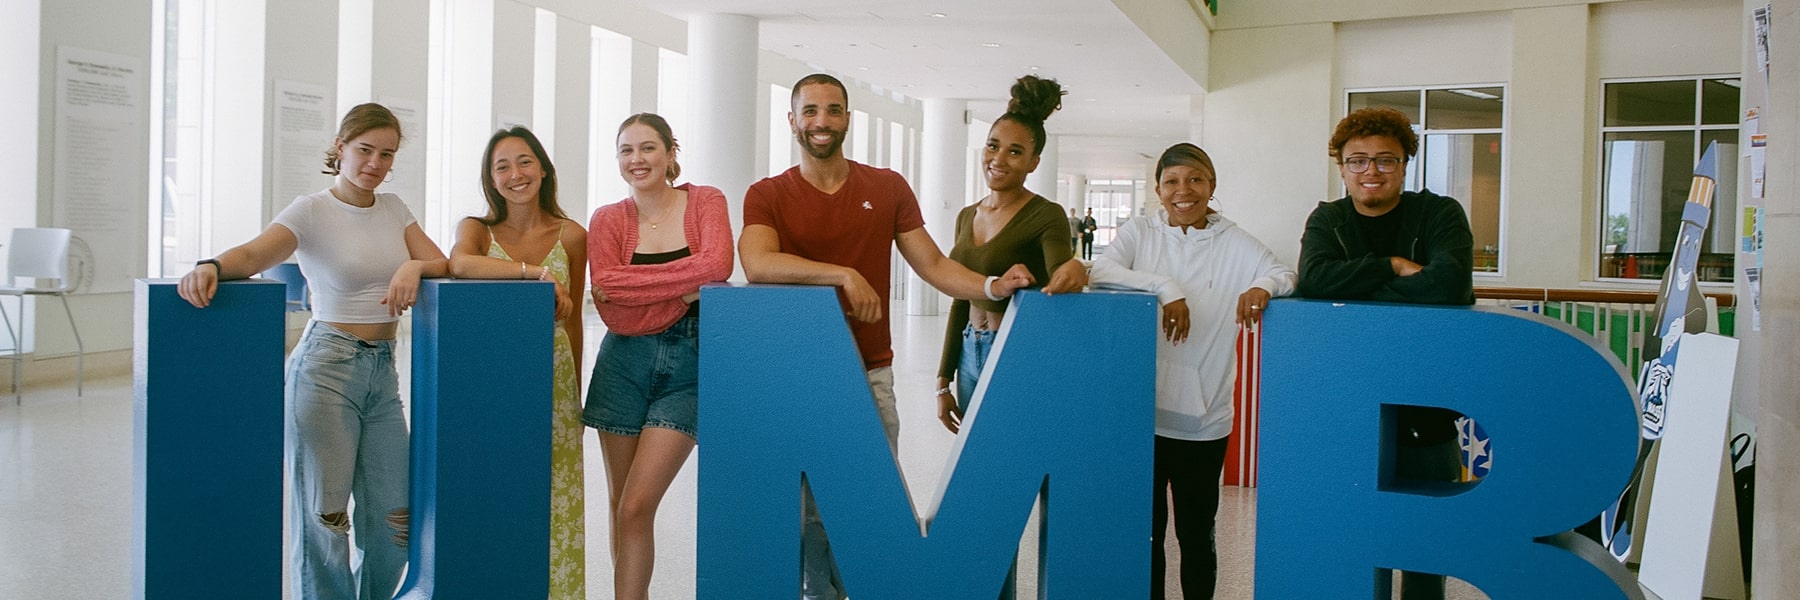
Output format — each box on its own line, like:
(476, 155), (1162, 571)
(1300, 108), (1474, 600)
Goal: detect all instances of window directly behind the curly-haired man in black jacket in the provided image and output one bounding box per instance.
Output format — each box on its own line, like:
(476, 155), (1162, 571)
(1350, 86), (1507, 274)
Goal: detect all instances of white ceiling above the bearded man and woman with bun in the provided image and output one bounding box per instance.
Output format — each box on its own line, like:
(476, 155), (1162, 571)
(639, 0), (1201, 178)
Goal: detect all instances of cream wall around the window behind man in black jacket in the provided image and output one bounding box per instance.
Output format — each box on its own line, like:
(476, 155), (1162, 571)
(1202, 0), (1742, 288)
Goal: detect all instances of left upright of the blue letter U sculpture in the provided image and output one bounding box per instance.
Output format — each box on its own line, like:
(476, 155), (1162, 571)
(131, 279), (284, 600)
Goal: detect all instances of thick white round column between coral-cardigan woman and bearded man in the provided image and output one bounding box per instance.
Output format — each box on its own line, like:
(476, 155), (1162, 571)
(675, 14), (760, 234)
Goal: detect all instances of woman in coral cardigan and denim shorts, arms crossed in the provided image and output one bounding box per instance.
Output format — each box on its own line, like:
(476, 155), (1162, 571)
(581, 114), (733, 600)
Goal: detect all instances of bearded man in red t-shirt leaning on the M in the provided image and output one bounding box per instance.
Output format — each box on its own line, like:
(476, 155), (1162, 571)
(738, 74), (1031, 600)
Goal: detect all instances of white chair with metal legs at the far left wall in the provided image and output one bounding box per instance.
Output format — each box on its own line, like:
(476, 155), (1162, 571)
(0, 227), (86, 404)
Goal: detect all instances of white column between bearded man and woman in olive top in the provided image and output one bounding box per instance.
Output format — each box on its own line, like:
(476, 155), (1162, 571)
(905, 99), (968, 315)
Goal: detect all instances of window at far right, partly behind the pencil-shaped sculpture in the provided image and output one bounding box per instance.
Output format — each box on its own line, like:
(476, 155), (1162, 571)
(1598, 77), (1739, 283)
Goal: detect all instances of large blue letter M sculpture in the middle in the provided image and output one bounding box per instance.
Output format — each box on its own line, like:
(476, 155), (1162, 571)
(698, 286), (1156, 600)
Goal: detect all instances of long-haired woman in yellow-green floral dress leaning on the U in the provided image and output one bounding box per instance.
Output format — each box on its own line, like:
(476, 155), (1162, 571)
(450, 126), (587, 600)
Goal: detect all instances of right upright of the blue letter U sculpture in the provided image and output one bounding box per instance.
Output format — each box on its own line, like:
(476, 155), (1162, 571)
(400, 279), (554, 600)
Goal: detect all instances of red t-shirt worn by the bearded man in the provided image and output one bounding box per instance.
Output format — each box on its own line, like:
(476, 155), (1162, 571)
(743, 160), (925, 369)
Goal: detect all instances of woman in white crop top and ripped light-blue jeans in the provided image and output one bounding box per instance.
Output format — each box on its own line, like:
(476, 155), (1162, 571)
(180, 103), (450, 600)
